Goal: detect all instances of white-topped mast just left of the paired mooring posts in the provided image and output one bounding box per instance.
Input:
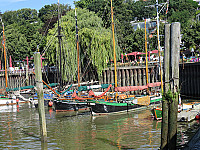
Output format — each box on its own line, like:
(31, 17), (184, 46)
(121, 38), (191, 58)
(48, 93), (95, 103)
(156, 0), (163, 92)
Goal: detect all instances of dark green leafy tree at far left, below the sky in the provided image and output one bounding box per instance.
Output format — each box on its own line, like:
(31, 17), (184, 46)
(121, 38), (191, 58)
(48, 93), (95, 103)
(3, 9), (45, 60)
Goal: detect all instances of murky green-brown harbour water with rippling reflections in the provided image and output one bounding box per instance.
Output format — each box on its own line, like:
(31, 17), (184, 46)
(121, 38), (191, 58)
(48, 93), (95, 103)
(0, 104), (198, 150)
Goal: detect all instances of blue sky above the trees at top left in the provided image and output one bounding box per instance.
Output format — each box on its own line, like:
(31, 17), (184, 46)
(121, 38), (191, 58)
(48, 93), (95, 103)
(0, 0), (78, 13)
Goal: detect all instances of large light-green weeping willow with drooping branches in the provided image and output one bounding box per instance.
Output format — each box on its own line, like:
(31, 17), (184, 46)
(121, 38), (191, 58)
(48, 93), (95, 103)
(46, 8), (120, 81)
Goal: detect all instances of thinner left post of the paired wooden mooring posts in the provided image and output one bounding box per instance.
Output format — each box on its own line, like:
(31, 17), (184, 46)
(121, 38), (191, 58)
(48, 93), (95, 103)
(160, 24), (170, 150)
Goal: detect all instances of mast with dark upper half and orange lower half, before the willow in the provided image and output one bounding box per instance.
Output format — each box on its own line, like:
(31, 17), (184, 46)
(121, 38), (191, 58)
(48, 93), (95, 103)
(75, 8), (80, 87)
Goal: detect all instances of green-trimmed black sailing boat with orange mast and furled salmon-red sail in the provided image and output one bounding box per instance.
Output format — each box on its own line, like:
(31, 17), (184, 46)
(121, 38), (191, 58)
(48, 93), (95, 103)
(90, 0), (162, 115)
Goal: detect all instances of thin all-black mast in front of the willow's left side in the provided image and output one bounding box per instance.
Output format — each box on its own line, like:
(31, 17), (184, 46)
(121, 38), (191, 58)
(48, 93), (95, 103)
(57, 0), (63, 91)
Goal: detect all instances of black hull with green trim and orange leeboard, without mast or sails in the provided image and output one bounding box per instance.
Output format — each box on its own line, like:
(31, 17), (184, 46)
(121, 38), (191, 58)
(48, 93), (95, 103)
(90, 96), (162, 115)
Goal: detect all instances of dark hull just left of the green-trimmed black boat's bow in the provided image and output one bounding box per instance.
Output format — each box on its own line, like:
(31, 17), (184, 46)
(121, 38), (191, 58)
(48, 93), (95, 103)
(53, 100), (89, 112)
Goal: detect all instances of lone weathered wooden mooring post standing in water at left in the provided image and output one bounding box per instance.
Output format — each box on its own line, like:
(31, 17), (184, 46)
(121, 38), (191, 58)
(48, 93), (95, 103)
(34, 52), (47, 142)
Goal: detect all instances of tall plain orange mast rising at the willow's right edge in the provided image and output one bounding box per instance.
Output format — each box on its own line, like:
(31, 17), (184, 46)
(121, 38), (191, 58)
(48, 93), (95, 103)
(111, 0), (117, 90)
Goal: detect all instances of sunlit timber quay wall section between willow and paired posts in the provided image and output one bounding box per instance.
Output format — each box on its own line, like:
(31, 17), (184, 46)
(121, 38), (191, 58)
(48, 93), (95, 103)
(101, 66), (160, 86)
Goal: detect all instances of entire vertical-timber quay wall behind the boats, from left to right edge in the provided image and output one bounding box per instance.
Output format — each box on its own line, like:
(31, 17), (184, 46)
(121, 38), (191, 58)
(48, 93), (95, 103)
(0, 62), (200, 99)
